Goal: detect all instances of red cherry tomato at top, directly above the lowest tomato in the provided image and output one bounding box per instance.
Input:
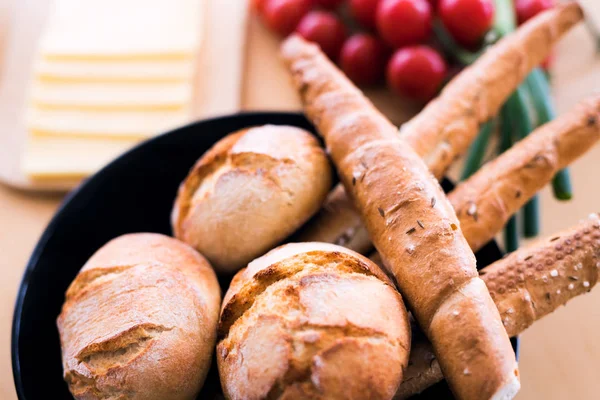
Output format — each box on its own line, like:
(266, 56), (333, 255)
(376, 0), (431, 48)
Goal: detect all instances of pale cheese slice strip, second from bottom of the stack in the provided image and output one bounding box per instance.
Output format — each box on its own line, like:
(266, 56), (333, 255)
(27, 107), (190, 138)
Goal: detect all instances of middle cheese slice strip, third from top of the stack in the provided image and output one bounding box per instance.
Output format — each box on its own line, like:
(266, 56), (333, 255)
(31, 81), (192, 110)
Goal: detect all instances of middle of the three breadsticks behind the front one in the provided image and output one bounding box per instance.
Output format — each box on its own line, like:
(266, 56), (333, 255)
(448, 96), (600, 251)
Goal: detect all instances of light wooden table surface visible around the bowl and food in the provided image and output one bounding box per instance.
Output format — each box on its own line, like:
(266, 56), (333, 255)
(0, 0), (600, 400)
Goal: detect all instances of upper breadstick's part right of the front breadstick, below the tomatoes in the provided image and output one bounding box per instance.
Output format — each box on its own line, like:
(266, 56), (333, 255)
(400, 2), (583, 178)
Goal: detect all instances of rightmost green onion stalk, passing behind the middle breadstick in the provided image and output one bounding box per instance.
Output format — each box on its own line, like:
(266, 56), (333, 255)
(526, 68), (573, 200)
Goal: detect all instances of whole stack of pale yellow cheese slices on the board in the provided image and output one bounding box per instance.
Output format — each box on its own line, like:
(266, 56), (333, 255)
(23, 0), (204, 180)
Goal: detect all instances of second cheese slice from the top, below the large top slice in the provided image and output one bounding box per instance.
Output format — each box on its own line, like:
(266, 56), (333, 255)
(34, 59), (194, 82)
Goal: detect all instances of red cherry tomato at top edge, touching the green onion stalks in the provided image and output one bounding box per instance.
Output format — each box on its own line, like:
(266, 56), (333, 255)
(438, 0), (494, 48)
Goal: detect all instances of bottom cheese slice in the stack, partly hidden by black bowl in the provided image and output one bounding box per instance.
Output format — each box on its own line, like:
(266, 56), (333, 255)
(23, 137), (138, 180)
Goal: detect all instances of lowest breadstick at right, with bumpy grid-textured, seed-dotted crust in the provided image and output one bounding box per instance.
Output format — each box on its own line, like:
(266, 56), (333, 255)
(395, 214), (600, 399)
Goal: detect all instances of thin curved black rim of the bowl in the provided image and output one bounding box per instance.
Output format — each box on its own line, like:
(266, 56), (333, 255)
(10, 110), (521, 399)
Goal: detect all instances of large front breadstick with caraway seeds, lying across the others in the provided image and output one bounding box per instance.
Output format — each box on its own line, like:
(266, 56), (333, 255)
(282, 36), (520, 399)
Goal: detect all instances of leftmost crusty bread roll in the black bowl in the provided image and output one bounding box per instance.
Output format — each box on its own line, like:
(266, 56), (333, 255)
(57, 233), (221, 400)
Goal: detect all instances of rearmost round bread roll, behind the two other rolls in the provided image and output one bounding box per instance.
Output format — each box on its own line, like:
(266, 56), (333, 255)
(172, 125), (332, 273)
